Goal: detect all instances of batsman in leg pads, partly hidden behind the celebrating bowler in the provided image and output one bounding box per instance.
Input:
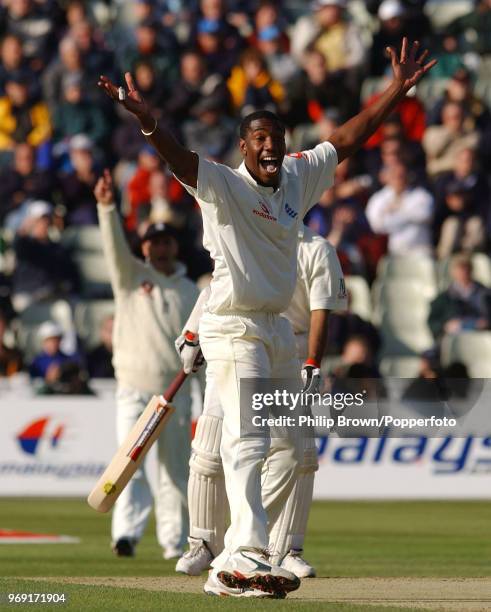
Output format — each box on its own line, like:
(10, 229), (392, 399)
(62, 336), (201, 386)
(176, 227), (347, 578)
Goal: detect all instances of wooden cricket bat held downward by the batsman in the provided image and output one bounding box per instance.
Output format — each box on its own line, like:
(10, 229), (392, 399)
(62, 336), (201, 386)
(87, 370), (187, 512)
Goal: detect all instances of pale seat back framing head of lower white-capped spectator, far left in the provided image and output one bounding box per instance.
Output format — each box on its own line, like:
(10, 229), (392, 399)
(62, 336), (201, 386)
(16, 300), (76, 363)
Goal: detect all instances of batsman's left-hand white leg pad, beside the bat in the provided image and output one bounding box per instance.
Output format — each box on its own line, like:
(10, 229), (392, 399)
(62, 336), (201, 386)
(188, 414), (228, 556)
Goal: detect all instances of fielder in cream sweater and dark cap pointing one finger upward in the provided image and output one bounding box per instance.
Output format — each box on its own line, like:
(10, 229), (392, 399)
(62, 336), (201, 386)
(94, 170), (199, 559)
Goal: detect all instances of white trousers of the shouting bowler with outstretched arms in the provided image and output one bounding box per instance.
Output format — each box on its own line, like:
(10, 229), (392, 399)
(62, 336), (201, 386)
(199, 313), (302, 566)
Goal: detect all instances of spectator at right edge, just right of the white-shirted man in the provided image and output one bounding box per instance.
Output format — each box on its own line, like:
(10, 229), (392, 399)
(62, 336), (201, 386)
(437, 181), (486, 259)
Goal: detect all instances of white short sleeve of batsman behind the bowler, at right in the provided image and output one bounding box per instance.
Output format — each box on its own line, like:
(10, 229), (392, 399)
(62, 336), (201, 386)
(309, 244), (348, 311)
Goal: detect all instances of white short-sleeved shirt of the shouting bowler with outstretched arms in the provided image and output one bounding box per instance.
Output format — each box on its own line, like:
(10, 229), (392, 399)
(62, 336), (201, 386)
(183, 142), (338, 314)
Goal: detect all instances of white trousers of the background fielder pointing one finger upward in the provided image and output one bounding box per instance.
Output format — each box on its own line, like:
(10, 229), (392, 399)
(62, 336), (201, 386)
(112, 388), (191, 551)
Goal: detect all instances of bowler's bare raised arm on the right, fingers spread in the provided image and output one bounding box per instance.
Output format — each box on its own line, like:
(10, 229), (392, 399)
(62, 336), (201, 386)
(329, 38), (437, 163)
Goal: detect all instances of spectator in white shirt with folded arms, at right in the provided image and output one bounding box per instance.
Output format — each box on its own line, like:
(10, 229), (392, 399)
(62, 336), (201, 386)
(366, 163), (434, 255)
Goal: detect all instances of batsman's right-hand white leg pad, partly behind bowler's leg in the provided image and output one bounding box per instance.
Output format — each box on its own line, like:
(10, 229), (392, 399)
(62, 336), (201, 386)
(269, 438), (319, 563)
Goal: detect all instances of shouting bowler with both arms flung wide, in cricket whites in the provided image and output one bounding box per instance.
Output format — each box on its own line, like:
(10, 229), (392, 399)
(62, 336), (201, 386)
(99, 38), (436, 597)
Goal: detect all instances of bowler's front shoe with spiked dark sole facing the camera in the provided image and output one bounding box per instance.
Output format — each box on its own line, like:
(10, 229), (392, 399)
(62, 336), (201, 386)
(215, 549), (300, 597)
